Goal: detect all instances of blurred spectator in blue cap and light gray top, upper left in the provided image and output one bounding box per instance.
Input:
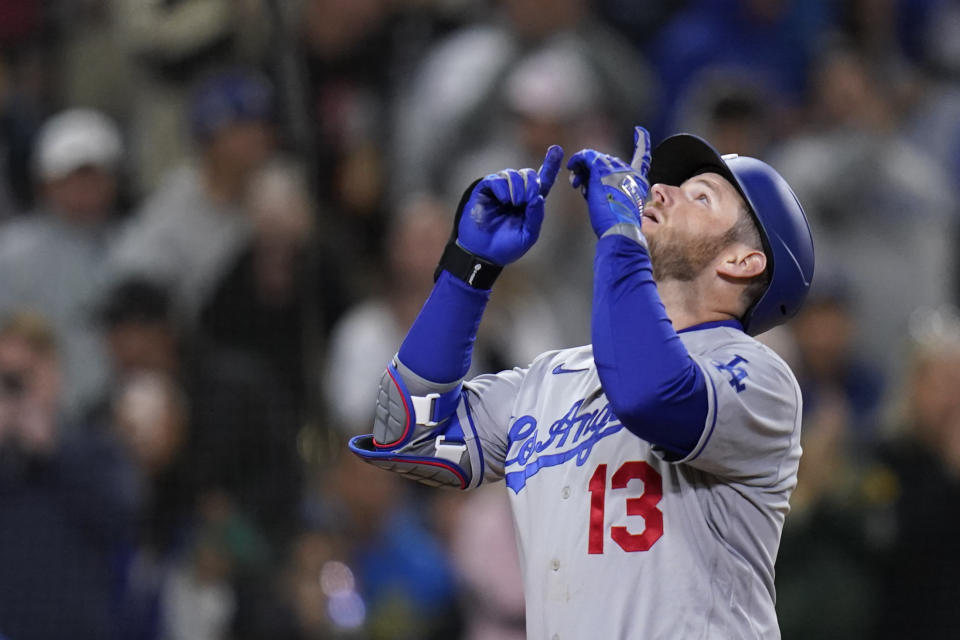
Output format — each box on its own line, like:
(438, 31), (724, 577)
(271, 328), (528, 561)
(111, 69), (274, 328)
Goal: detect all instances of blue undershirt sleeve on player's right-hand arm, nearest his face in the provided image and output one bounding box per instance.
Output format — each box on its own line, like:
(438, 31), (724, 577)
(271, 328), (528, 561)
(591, 235), (708, 458)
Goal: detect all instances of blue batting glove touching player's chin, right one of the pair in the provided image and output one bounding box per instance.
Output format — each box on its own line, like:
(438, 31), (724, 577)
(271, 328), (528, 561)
(567, 127), (650, 238)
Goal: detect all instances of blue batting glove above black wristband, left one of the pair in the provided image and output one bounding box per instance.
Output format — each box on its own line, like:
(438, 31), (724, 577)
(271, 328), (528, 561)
(457, 145), (563, 266)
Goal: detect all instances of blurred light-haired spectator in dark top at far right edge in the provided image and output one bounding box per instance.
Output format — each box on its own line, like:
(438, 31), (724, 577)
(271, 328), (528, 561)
(871, 307), (960, 639)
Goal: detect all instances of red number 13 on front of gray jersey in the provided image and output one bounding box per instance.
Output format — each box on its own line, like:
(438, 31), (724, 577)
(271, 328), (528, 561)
(588, 460), (663, 553)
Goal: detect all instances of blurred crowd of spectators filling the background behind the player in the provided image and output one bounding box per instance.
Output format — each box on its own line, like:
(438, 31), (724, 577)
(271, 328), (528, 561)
(0, 0), (960, 640)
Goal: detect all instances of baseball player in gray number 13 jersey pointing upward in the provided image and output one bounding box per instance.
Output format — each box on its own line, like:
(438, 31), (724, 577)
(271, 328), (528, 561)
(350, 127), (813, 639)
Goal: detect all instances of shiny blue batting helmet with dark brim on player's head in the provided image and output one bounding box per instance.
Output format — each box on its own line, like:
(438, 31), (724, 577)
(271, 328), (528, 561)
(648, 133), (814, 336)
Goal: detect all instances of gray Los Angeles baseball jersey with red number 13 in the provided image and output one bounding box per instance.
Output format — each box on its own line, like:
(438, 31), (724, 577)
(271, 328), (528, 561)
(464, 326), (801, 640)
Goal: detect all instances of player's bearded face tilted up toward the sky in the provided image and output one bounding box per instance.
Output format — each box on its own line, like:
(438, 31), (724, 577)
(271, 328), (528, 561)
(643, 173), (745, 281)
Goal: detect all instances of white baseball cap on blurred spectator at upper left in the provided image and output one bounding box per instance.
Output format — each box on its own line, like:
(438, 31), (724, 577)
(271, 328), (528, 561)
(34, 109), (123, 180)
